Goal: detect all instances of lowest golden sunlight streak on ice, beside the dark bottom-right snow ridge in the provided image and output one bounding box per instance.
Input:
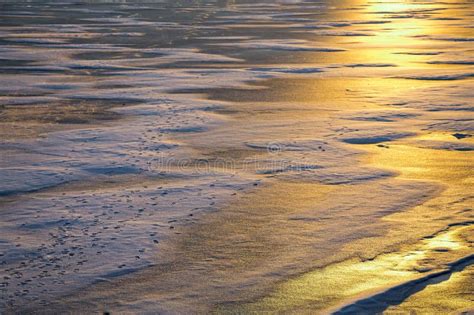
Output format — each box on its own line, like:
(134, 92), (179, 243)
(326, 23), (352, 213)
(224, 226), (474, 313)
